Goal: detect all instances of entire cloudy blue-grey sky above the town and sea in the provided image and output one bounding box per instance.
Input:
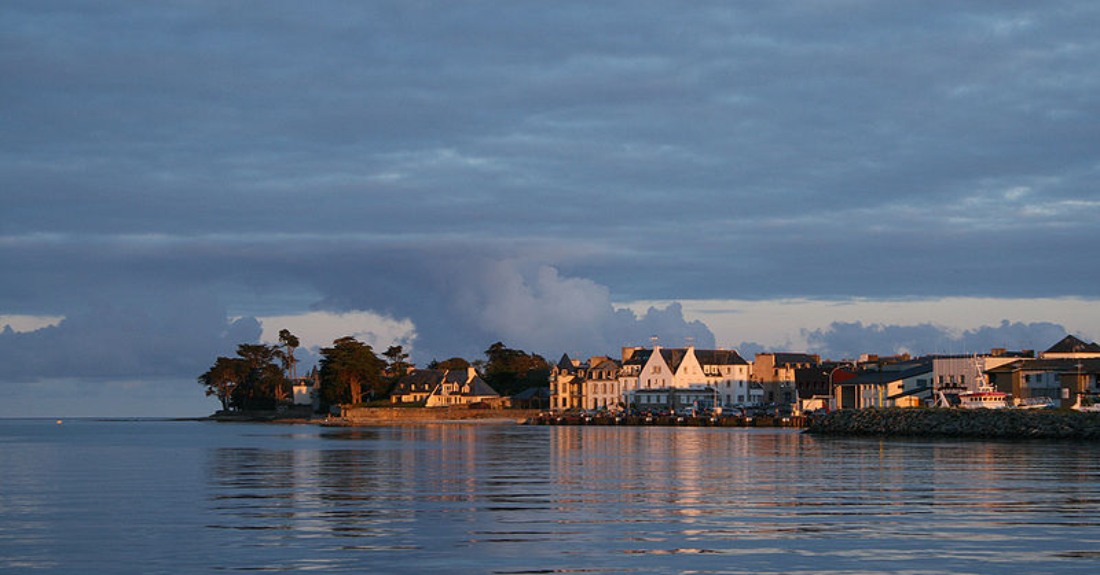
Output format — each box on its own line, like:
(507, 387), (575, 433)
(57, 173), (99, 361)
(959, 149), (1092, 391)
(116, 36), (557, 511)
(0, 0), (1100, 417)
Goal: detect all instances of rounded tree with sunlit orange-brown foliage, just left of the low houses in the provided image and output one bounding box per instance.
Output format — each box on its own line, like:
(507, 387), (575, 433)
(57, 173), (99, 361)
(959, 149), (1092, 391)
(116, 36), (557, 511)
(320, 338), (385, 405)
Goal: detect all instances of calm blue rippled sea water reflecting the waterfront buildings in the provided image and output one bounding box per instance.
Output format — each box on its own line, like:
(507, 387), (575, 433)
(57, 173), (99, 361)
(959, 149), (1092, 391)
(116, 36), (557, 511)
(0, 420), (1100, 575)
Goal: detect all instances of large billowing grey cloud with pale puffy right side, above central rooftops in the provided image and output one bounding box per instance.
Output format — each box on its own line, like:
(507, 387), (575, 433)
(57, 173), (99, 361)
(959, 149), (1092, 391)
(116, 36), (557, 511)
(314, 254), (714, 360)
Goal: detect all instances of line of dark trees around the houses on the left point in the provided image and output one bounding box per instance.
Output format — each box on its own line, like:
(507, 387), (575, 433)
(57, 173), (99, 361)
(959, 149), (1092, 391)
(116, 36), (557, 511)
(198, 330), (550, 411)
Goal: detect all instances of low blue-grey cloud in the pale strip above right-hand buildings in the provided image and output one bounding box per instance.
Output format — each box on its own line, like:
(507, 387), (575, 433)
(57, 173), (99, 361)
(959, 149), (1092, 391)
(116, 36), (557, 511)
(803, 320), (1067, 360)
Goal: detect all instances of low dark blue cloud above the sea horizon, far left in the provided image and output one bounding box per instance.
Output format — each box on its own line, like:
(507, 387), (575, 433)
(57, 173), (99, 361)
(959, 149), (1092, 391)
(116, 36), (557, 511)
(0, 292), (260, 383)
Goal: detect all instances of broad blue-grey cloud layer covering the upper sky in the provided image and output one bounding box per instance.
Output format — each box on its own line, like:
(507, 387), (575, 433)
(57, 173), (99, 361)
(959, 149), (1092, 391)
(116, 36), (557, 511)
(0, 1), (1100, 303)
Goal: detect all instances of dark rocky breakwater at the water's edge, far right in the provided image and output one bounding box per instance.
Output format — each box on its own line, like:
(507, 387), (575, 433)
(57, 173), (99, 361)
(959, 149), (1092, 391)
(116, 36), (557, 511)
(805, 409), (1100, 441)
